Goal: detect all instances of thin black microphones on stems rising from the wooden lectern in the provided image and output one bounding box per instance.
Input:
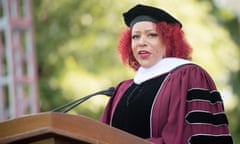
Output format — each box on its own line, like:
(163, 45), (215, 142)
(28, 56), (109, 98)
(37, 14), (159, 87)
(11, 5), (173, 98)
(51, 87), (115, 113)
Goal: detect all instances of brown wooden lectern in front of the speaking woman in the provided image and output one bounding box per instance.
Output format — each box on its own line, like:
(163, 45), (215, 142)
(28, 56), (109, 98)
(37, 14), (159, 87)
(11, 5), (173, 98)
(0, 112), (150, 144)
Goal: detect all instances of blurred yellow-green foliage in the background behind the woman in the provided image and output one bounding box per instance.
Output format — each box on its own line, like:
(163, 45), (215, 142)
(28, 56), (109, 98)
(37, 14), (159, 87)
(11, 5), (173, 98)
(32, 0), (240, 144)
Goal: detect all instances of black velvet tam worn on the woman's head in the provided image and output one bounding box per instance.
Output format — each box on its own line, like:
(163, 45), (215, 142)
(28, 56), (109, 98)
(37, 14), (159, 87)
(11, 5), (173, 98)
(123, 4), (182, 27)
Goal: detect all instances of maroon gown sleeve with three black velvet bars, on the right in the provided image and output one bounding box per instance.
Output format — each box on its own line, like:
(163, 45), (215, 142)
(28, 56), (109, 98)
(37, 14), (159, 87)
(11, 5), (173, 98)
(148, 64), (233, 144)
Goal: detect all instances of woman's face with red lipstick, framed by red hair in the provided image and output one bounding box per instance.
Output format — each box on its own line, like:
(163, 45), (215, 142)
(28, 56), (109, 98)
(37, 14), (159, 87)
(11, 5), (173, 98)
(131, 21), (165, 68)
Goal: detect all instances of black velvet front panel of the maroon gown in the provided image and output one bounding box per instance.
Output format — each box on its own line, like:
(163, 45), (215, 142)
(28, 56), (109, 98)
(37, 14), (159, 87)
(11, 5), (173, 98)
(112, 74), (167, 138)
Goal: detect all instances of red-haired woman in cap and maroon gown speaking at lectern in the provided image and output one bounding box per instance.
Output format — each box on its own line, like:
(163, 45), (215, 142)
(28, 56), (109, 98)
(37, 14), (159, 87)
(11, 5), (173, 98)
(101, 5), (233, 144)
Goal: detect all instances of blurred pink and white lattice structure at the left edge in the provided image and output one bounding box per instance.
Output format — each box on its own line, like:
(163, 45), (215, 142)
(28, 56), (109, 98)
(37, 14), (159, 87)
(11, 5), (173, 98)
(0, 0), (39, 121)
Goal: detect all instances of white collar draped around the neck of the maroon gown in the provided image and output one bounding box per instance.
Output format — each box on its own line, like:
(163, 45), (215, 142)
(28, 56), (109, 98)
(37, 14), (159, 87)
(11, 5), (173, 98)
(134, 57), (192, 84)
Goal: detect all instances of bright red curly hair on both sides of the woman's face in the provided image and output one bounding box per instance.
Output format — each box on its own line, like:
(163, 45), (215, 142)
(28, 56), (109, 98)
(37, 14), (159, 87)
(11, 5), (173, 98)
(118, 22), (192, 70)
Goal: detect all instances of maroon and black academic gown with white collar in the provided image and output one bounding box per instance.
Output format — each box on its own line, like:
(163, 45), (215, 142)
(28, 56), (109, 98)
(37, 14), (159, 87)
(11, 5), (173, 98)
(101, 58), (233, 144)
